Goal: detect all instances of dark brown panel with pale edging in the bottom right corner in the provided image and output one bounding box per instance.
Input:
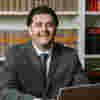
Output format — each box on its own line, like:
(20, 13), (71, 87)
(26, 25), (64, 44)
(57, 83), (100, 100)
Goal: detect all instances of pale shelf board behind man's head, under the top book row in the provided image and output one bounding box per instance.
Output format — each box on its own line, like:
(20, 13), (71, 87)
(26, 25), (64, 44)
(0, 11), (79, 16)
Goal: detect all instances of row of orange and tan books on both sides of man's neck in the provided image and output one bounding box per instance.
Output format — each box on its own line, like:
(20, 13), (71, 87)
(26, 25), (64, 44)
(0, 29), (78, 55)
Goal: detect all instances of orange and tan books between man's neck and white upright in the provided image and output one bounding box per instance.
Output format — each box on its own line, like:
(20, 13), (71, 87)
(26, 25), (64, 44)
(55, 29), (78, 48)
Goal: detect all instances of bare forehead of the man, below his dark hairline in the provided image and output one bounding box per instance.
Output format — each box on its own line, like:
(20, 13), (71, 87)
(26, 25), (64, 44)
(32, 13), (53, 23)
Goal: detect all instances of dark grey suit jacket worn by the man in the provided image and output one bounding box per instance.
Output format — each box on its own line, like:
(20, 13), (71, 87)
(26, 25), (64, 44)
(8, 44), (87, 98)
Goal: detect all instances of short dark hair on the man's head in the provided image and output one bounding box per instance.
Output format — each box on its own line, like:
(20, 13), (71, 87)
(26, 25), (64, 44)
(26, 6), (59, 26)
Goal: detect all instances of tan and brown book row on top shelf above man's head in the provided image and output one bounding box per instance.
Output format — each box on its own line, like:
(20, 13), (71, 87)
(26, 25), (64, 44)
(0, 0), (79, 11)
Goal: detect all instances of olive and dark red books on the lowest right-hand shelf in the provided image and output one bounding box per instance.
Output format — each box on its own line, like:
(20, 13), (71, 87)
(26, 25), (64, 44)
(85, 58), (100, 83)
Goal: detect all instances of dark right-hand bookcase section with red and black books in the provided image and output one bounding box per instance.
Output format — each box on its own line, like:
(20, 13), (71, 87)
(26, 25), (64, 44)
(84, 0), (100, 81)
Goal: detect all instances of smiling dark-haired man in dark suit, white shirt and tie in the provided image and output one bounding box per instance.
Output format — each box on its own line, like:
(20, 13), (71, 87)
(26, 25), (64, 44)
(8, 6), (86, 100)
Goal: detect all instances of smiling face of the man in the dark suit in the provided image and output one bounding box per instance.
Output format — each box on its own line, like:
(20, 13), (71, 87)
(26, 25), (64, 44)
(31, 14), (56, 48)
